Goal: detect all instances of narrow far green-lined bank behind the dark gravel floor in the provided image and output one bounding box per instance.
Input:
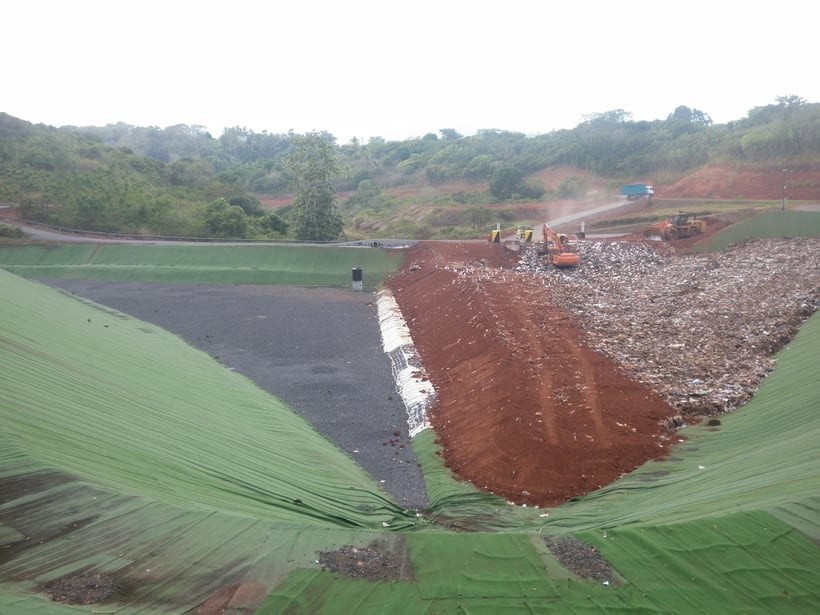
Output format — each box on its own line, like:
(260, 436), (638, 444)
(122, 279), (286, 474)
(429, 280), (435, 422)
(0, 244), (403, 288)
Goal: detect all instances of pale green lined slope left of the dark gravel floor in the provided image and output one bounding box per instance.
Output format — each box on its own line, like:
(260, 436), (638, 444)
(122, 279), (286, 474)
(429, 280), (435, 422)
(0, 271), (413, 528)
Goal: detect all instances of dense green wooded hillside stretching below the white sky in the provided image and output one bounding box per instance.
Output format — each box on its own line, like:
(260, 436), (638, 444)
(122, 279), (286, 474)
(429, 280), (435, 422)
(0, 96), (820, 240)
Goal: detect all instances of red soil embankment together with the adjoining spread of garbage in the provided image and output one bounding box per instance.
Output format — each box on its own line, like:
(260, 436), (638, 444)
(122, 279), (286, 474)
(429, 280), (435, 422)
(389, 229), (820, 506)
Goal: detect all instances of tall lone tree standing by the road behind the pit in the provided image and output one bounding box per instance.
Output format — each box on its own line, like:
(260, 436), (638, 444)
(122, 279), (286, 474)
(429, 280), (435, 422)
(286, 132), (344, 241)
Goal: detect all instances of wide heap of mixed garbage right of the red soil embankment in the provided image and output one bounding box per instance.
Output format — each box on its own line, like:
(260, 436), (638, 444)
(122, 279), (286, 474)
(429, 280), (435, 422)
(518, 238), (820, 417)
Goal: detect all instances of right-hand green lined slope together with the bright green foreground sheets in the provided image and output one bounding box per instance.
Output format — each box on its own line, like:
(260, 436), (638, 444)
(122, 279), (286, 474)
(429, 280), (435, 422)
(259, 317), (820, 614)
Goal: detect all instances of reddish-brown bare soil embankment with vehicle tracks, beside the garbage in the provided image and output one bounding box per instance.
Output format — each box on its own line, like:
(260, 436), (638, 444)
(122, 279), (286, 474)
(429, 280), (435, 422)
(388, 241), (676, 506)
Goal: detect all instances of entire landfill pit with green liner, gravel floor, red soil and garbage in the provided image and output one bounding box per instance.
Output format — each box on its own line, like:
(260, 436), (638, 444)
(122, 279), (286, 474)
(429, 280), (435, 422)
(0, 208), (820, 615)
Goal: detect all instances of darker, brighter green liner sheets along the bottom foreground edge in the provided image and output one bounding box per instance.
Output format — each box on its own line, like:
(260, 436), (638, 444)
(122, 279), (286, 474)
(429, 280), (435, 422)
(257, 512), (820, 615)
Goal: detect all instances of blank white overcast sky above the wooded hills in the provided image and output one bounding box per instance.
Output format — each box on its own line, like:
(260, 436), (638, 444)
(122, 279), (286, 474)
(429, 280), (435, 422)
(0, 0), (820, 143)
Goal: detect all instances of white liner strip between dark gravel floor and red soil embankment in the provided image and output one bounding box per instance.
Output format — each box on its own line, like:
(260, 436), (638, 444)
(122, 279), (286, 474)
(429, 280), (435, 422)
(376, 290), (436, 437)
